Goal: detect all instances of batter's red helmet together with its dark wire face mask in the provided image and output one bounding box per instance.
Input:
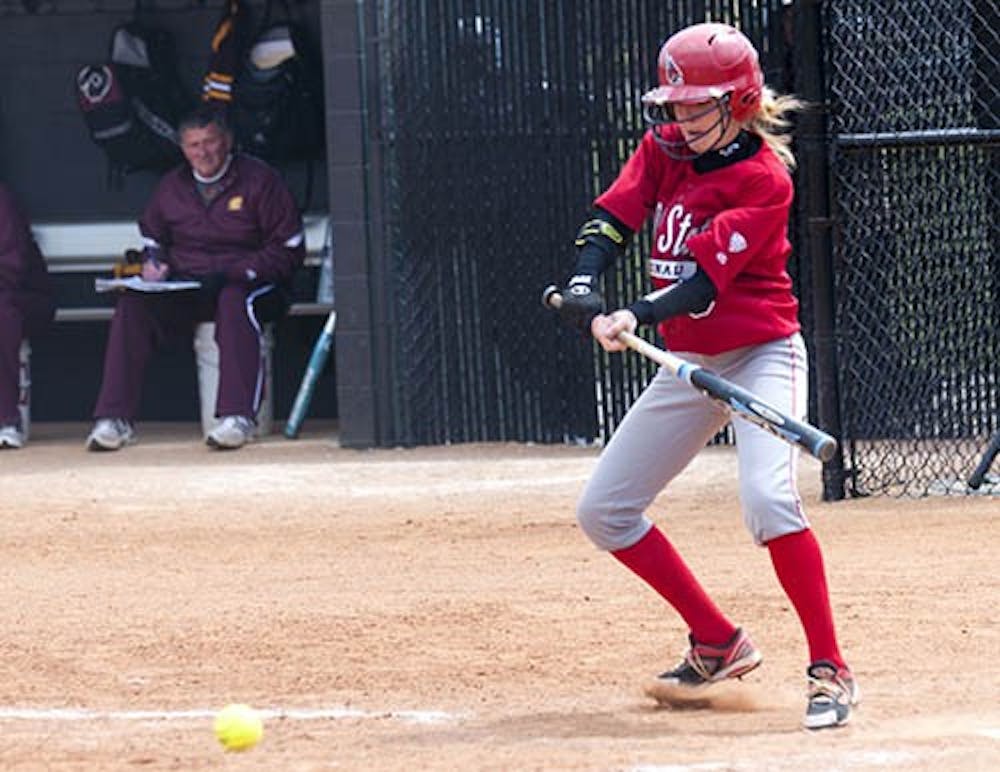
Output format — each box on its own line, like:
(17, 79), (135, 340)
(642, 23), (764, 158)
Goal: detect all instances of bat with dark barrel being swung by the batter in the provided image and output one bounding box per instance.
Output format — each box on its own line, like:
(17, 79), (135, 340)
(542, 285), (837, 461)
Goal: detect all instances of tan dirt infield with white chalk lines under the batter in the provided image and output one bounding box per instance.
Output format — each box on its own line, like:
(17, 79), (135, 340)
(0, 425), (1000, 772)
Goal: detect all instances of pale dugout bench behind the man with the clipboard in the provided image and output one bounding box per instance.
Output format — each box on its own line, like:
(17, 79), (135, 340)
(22, 214), (333, 434)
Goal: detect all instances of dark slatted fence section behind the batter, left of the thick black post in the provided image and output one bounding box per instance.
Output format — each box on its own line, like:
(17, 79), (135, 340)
(379, 0), (786, 443)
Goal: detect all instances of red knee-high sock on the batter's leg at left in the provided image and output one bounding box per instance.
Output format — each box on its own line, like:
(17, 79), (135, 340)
(611, 526), (736, 645)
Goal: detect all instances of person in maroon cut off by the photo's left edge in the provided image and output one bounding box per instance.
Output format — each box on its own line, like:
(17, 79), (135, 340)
(0, 185), (55, 449)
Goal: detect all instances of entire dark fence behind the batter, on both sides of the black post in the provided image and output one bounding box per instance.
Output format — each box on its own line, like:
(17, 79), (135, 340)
(377, 0), (1000, 495)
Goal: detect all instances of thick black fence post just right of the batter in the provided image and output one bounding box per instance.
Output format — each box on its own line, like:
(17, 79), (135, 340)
(794, 0), (844, 501)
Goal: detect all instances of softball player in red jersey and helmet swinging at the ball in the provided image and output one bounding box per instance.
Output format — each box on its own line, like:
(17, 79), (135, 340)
(561, 19), (859, 729)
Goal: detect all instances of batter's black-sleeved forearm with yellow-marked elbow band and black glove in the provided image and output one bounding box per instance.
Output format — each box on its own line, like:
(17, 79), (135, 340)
(559, 209), (633, 332)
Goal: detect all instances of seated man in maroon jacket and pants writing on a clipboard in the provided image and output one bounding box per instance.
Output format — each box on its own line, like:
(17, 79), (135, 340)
(87, 108), (305, 450)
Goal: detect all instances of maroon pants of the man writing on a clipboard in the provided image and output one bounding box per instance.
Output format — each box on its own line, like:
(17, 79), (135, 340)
(94, 284), (274, 420)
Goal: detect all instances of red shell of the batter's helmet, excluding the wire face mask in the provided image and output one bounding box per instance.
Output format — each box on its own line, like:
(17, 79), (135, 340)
(642, 23), (764, 121)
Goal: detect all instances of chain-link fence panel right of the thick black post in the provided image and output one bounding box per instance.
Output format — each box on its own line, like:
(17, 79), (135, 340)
(825, 0), (1000, 495)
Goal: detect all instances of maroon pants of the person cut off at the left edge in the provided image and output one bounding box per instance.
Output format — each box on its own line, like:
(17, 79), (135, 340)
(0, 288), (55, 426)
